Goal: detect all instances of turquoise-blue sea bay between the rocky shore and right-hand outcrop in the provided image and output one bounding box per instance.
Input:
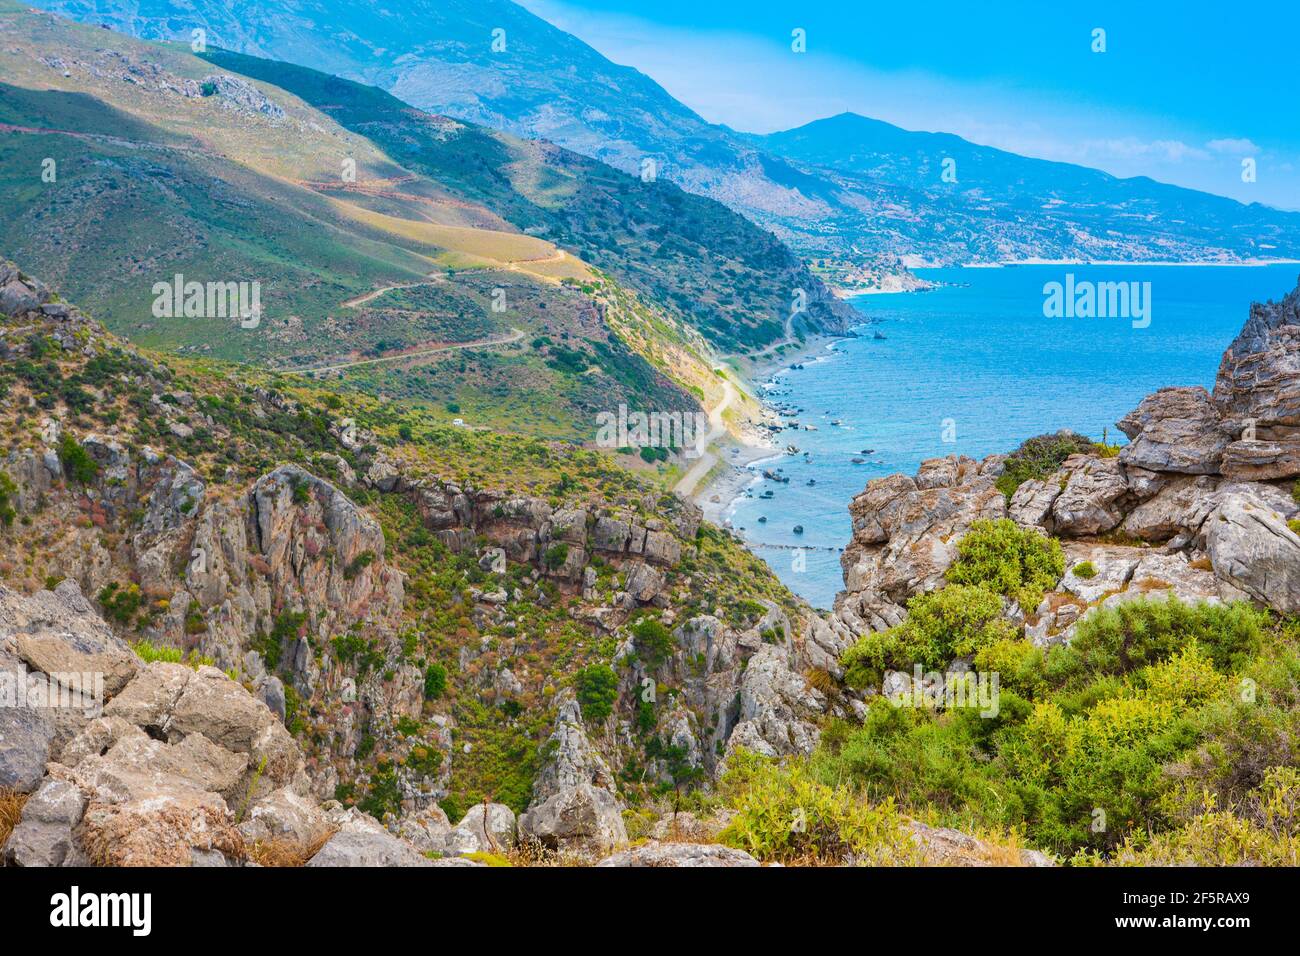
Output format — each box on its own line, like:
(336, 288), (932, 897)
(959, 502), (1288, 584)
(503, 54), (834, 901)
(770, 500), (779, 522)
(727, 264), (1300, 607)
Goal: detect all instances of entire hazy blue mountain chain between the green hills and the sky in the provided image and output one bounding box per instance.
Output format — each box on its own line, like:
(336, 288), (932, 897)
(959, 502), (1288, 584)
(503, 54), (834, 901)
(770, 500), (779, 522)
(32, 0), (1300, 289)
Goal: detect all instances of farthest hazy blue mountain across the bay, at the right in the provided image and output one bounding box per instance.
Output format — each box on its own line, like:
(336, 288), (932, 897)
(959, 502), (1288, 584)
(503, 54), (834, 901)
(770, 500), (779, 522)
(746, 113), (1300, 269)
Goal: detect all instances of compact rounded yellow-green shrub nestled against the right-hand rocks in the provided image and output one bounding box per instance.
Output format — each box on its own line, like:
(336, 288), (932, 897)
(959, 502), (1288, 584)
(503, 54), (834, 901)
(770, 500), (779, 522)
(946, 518), (1065, 611)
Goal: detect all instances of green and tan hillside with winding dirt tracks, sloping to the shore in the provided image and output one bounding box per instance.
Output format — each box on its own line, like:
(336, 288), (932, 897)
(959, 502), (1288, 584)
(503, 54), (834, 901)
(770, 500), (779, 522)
(0, 0), (854, 440)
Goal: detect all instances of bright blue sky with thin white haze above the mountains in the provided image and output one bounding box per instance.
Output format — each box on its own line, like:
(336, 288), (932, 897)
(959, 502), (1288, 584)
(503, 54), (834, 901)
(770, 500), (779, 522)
(520, 0), (1300, 209)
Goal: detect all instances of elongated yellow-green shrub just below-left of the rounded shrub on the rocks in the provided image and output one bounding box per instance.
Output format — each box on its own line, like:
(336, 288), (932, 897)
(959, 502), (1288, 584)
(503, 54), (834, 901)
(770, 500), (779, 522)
(840, 584), (1017, 688)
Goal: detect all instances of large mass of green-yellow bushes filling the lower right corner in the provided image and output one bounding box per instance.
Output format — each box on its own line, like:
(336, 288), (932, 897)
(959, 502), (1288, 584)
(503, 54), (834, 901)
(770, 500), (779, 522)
(826, 598), (1300, 862)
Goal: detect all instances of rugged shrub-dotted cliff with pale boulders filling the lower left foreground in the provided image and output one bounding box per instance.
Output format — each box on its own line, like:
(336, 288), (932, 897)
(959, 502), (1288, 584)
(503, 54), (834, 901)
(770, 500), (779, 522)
(0, 264), (850, 865)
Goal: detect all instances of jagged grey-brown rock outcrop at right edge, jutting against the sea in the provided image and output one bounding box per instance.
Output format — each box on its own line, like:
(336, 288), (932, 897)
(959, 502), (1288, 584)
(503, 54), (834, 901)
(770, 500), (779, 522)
(835, 277), (1300, 641)
